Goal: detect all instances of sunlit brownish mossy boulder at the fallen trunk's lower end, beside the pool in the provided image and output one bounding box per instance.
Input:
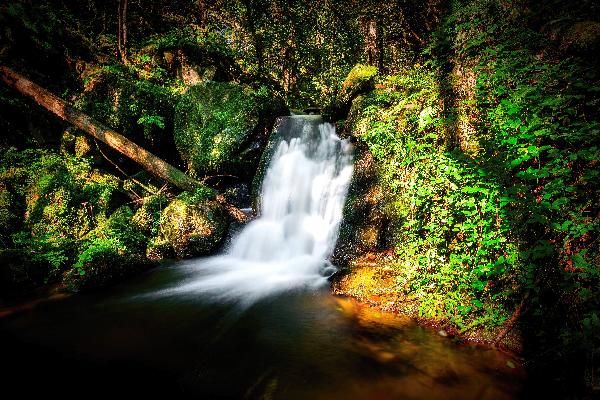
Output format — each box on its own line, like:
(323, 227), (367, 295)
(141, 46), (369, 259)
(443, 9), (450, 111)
(148, 190), (230, 260)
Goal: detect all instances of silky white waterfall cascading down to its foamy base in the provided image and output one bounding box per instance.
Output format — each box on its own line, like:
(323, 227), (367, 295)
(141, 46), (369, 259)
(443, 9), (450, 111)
(161, 116), (353, 303)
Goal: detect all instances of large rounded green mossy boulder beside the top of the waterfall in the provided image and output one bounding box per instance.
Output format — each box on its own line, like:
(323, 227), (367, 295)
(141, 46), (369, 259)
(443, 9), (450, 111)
(175, 82), (288, 178)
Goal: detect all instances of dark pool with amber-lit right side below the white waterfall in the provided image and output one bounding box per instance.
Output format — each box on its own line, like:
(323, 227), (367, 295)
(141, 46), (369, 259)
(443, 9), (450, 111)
(0, 264), (523, 399)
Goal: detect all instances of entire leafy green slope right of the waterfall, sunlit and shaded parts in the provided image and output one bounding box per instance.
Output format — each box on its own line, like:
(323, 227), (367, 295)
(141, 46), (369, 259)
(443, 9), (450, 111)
(348, 1), (600, 337)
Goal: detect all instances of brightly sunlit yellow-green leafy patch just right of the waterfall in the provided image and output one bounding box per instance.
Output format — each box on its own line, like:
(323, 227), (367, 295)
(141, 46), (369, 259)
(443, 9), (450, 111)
(352, 66), (520, 330)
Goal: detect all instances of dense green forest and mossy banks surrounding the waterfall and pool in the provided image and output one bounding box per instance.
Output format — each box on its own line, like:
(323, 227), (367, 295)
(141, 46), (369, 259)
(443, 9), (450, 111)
(0, 0), (600, 397)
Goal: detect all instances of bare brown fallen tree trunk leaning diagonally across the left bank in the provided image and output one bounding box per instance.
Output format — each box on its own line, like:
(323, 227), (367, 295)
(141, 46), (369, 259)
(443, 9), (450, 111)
(0, 66), (201, 190)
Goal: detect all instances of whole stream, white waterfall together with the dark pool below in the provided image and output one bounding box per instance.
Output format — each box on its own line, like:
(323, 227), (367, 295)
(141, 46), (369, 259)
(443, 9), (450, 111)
(0, 117), (524, 400)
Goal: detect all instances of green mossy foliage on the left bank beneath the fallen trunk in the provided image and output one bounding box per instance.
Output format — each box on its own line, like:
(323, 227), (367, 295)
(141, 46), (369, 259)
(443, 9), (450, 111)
(0, 149), (157, 289)
